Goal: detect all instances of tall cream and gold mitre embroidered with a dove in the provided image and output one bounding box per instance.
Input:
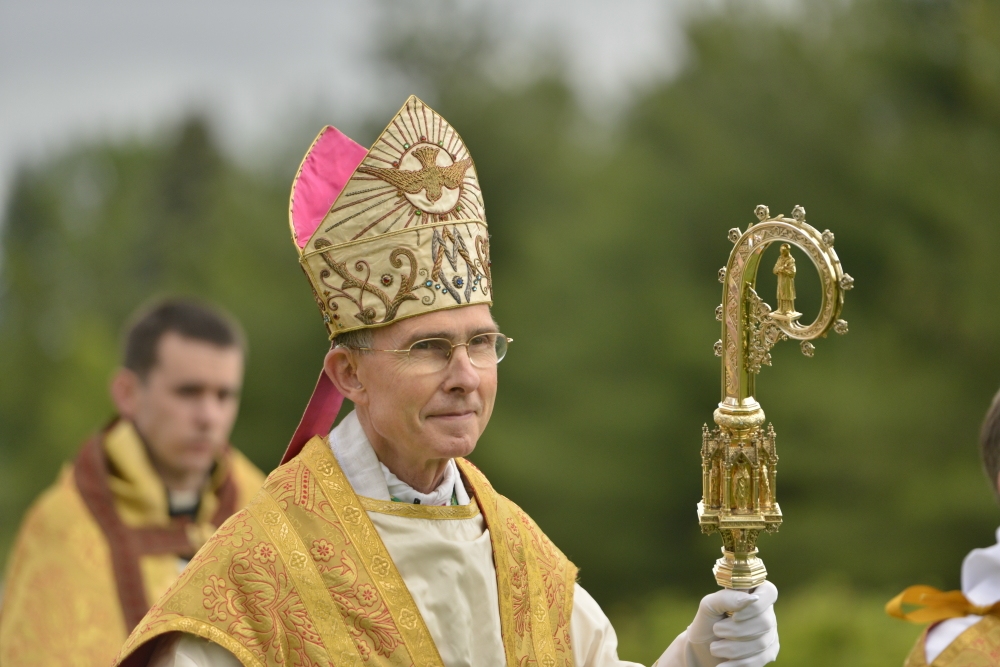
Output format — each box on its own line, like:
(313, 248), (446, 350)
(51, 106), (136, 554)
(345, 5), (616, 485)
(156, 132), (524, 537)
(289, 96), (493, 338)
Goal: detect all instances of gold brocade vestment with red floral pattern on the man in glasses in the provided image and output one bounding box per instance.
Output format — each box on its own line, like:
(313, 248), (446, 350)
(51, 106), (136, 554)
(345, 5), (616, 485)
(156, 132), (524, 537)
(117, 436), (577, 667)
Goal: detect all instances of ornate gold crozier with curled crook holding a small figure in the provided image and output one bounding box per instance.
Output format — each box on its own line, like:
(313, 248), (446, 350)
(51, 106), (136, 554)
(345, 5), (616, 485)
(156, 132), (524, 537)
(698, 206), (854, 590)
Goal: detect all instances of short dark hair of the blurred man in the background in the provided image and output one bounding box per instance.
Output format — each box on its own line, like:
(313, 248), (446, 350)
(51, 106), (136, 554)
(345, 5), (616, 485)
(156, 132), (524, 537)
(122, 298), (246, 380)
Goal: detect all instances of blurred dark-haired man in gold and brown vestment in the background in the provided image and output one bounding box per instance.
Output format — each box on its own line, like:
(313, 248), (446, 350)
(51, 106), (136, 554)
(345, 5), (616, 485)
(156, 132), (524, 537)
(0, 300), (264, 667)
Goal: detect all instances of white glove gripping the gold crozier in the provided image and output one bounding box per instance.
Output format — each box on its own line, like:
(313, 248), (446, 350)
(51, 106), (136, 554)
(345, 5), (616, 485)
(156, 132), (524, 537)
(655, 581), (778, 667)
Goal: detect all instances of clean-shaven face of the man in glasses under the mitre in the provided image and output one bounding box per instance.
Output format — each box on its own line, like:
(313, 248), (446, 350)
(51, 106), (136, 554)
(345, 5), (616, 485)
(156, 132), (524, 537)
(357, 304), (497, 458)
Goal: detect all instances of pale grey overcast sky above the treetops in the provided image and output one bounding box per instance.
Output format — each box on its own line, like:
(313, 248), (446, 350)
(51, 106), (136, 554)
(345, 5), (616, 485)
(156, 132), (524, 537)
(0, 0), (688, 209)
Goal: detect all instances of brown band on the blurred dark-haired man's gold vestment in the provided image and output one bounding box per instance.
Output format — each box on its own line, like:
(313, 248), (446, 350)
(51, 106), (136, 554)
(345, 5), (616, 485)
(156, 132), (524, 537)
(73, 422), (237, 633)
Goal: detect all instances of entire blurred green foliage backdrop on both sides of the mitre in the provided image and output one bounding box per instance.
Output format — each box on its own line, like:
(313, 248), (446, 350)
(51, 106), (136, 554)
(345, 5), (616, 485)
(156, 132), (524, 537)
(0, 0), (1000, 667)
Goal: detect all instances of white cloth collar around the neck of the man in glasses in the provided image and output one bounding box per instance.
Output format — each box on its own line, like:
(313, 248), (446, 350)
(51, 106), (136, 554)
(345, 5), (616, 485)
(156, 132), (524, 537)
(329, 410), (469, 505)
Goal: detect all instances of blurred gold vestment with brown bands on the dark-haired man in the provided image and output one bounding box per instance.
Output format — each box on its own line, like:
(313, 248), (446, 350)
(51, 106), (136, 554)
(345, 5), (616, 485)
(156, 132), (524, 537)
(0, 421), (263, 667)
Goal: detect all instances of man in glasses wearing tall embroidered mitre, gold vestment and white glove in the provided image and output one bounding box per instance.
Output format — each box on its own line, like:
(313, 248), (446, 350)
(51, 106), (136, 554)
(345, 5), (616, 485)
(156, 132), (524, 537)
(111, 97), (778, 667)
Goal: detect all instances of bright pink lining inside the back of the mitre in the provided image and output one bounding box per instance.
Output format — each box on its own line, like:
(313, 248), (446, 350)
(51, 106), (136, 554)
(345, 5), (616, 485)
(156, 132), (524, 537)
(292, 127), (368, 248)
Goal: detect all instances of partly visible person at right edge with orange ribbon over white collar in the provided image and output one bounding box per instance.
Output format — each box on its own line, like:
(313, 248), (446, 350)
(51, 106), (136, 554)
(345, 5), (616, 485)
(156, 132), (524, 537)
(886, 392), (1000, 667)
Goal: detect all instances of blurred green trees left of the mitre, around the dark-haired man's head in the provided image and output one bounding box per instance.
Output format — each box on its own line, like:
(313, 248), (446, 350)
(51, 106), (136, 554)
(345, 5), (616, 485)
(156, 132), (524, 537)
(0, 118), (324, 551)
